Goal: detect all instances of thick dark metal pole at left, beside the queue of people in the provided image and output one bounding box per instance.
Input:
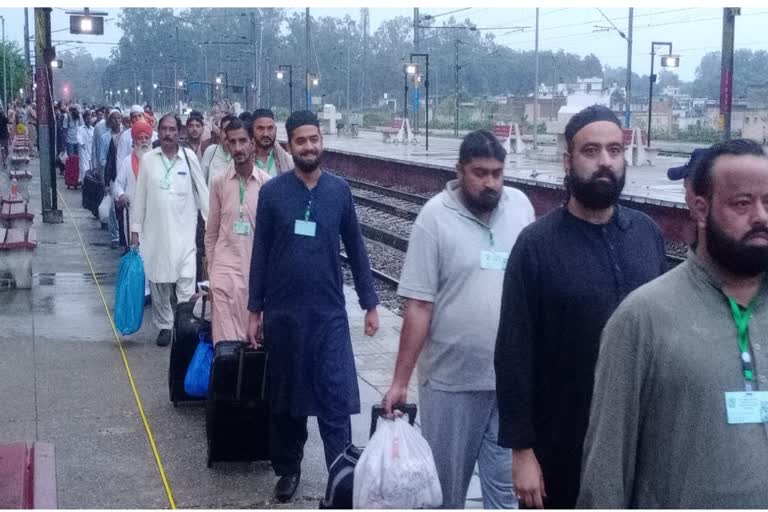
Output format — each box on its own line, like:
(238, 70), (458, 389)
(35, 7), (64, 224)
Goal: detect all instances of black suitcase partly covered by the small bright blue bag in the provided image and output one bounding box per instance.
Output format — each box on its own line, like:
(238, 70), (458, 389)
(168, 298), (211, 407)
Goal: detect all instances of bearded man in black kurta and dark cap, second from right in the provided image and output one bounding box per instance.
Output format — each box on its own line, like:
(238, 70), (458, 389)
(495, 105), (666, 508)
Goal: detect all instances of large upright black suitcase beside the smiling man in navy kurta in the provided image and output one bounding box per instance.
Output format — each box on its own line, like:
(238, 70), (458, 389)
(205, 341), (270, 468)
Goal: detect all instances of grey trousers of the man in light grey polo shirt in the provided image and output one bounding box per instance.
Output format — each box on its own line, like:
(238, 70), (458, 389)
(419, 382), (518, 509)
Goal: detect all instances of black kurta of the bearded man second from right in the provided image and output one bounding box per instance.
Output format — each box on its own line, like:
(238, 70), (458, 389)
(495, 206), (666, 508)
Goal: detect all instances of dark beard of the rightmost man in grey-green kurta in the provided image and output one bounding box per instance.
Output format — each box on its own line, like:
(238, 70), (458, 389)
(705, 213), (768, 277)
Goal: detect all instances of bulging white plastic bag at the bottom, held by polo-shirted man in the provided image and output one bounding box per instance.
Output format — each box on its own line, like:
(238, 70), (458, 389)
(352, 418), (443, 509)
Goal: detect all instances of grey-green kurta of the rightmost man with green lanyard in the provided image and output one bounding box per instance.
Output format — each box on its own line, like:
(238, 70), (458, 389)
(578, 253), (768, 509)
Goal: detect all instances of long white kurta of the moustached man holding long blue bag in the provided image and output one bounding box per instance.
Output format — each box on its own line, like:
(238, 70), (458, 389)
(128, 147), (208, 283)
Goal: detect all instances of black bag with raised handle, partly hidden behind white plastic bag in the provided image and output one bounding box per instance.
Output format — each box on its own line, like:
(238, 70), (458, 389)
(320, 404), (416, 509)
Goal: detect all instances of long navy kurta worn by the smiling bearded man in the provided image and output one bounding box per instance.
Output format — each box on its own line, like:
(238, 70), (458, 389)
(248, 171), (378, 417)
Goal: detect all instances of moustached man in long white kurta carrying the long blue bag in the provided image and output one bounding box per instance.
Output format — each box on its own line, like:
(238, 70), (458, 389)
(131, 114), (208, 347)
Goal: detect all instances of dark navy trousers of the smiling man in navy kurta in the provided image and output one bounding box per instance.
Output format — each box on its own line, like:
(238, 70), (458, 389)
(270, 414), (352, 476)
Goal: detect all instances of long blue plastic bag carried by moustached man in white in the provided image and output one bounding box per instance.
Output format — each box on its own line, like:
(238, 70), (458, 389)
(115, 247), (144, 335)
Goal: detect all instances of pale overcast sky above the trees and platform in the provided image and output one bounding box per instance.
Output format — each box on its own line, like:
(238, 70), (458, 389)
(0, 2), (768, 81)
